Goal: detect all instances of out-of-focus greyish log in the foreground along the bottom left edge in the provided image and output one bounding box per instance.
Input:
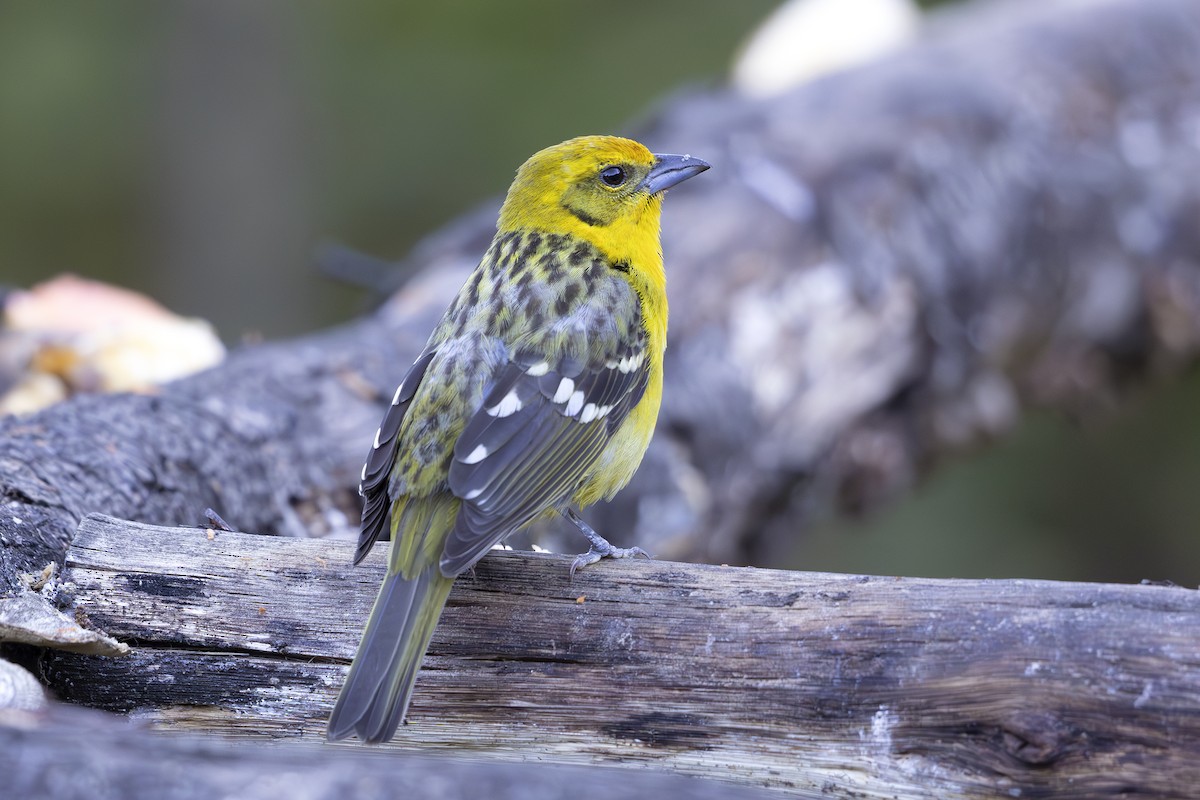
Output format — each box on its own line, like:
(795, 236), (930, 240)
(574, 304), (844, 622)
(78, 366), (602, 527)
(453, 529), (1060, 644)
(0, 705), (777, 800)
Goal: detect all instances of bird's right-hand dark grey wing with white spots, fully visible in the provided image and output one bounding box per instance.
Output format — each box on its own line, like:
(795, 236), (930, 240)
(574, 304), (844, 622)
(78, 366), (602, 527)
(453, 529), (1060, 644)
(442, 326), (649, 576)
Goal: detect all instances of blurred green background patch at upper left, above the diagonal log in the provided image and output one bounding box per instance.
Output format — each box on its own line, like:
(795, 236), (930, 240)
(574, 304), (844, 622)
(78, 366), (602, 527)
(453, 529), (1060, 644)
(0, 0), (773, 339)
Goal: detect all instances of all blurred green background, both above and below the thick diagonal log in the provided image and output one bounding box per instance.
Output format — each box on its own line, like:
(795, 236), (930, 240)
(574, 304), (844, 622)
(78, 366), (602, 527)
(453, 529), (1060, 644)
(0, 0), (1200, 585)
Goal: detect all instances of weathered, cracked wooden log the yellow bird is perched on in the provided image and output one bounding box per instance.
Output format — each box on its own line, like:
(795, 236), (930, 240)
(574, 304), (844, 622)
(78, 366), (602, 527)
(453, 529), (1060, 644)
(35, 517), (1200, 798)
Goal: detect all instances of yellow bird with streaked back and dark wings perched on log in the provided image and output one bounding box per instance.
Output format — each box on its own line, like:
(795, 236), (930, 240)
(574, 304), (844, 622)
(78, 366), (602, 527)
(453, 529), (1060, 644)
(328, 136), (709, 744)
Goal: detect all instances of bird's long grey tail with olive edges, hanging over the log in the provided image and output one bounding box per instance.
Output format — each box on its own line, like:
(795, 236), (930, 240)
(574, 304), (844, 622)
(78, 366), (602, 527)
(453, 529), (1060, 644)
(328, 501), (454, 744)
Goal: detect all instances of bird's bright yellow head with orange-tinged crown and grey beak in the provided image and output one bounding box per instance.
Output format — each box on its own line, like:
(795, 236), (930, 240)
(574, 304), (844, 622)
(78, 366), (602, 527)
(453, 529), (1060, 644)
(498, 136), (708, 259)
